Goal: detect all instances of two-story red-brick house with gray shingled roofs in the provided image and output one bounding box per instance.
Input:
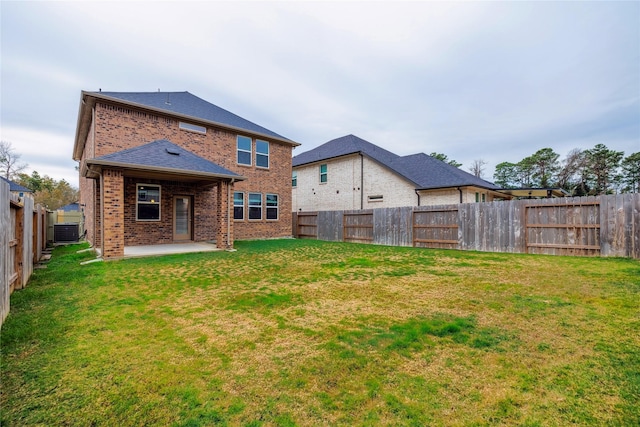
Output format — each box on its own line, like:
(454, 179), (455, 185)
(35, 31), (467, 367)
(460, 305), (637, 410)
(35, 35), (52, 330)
(73, 91), (299, 259)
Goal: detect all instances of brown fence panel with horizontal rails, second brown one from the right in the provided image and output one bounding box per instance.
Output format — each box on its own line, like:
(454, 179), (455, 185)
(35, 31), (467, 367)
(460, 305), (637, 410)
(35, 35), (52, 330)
(412, 207), (459, 249)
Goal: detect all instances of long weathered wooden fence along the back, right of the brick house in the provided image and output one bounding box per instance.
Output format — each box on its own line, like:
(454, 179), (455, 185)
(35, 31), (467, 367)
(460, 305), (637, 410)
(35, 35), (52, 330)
(293, 194), (640, 259)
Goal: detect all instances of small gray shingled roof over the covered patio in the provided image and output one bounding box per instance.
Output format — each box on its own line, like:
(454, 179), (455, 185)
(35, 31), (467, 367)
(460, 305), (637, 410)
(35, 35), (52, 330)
(92, 139), (242, 179)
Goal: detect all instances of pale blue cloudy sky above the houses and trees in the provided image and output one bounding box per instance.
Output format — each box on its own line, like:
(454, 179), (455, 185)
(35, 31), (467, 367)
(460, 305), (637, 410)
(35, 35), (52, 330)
(0, 0), (640, 185)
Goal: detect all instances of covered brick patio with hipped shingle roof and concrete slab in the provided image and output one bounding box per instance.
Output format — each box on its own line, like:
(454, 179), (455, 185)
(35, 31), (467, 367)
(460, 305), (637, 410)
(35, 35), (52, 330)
(82, 140), (245, 260)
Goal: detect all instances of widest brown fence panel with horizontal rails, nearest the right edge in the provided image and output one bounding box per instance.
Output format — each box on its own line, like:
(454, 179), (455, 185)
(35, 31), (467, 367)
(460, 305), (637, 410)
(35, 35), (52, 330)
(525, 201), (600, 256)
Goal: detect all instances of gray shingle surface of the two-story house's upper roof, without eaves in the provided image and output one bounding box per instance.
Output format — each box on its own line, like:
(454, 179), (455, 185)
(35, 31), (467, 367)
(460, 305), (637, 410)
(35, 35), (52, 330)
(94, 92), (293, 143)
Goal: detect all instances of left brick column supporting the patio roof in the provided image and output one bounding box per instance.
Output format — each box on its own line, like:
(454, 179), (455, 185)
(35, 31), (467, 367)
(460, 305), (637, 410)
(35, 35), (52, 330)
(101, 169), (124, 259)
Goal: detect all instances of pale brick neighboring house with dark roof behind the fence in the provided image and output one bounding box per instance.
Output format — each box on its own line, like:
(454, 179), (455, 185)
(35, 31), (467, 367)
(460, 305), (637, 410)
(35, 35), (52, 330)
(292, 135), (511, 211)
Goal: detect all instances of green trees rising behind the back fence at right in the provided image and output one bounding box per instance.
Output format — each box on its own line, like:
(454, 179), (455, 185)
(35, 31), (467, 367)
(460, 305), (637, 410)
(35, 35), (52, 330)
(438, 144), (640, 196)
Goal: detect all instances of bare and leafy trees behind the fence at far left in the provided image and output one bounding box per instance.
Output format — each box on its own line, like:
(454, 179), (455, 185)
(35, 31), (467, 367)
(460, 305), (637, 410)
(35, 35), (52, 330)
(0, 141), (79, 210)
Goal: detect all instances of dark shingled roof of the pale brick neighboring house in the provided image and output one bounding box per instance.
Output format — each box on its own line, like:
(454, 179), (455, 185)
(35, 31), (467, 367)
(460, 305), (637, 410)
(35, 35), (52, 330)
(293, 135), (500, 190)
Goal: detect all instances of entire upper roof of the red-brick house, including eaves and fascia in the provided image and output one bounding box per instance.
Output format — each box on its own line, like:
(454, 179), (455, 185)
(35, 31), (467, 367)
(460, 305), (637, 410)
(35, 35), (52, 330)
(73, 91), (300, 160)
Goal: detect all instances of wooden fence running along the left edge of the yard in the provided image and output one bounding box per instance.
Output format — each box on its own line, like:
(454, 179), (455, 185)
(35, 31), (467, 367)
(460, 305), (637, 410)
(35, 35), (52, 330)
(0, 182), (47, 326)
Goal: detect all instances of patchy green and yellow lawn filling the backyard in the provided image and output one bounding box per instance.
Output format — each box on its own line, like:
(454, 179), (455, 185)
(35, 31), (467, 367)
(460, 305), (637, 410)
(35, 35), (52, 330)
(0, 240), (640, 426)
